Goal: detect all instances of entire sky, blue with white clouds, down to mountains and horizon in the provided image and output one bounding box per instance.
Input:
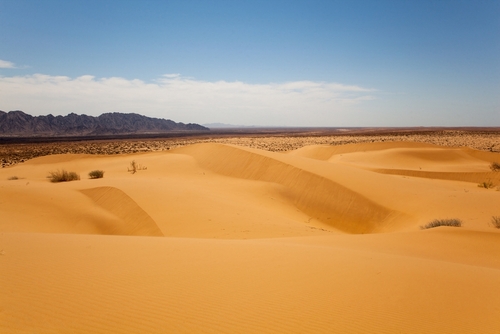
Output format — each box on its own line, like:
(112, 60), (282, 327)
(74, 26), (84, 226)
(0, 0), (500, 126)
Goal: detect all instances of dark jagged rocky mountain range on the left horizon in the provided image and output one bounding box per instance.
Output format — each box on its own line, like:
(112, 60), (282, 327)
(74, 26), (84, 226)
(0, 110), (209, 137)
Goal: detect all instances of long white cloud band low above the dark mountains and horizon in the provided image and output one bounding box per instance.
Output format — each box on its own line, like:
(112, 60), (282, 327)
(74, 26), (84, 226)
(0, 74), (375, 126)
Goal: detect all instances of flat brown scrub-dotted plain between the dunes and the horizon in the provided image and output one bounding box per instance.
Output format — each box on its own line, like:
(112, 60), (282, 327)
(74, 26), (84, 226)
(0, 131), (500, 168)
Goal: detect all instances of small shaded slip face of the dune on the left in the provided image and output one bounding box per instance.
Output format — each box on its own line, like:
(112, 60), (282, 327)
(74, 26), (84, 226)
(80, 187), (163, 236)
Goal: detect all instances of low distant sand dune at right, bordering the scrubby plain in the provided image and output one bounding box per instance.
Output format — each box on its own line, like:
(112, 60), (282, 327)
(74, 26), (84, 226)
(290, 142), (500, 184)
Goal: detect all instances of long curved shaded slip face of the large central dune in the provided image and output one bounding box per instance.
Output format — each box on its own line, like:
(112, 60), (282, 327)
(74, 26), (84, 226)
(180, 144), (407, 233)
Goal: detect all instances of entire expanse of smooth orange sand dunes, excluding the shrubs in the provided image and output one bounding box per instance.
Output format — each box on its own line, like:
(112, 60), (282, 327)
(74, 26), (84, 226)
(0, 142), (500, 333)
